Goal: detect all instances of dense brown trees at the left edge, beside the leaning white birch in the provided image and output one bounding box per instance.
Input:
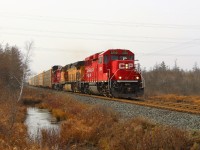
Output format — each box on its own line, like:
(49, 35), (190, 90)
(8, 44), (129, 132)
(0, 44), (24, 90)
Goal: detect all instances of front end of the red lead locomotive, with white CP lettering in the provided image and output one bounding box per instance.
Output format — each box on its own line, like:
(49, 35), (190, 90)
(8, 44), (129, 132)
(104, 50), (144, 98)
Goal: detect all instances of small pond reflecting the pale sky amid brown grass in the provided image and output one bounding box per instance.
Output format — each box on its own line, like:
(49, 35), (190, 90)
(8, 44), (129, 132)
(25, 108), (60, 141)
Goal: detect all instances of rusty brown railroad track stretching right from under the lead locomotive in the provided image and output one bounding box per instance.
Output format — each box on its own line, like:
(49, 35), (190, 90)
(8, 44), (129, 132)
(70, 93), (200, 114)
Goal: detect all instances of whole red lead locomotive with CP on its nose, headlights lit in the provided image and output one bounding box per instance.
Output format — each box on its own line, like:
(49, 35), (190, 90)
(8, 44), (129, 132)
(84, 49), (144, 98)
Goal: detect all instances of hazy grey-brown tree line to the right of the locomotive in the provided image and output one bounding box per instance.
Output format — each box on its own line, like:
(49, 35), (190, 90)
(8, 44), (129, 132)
(142, 61), (200, 96)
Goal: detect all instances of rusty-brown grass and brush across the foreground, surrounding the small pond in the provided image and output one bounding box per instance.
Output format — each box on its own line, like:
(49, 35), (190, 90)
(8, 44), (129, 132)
(0, 86), (200, 150)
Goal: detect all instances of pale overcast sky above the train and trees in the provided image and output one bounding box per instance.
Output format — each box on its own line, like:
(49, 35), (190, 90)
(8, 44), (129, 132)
(0, 0), (200, 73)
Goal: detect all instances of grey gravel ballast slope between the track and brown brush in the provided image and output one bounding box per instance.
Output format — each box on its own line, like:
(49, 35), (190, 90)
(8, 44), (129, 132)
(70, 94), (200, 130)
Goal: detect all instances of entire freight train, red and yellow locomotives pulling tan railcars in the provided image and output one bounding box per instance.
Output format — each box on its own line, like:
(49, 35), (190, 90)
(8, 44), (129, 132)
(29, 49), (144, 99)
